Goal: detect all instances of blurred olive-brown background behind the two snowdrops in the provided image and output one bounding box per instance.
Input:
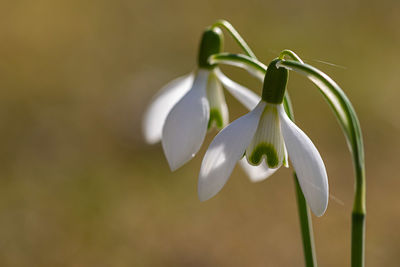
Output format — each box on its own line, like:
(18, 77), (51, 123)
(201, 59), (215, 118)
(0, 0), (400, 266)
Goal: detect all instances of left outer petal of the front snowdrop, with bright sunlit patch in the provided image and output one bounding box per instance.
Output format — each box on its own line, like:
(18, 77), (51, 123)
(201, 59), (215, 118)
(198, 101), (265, 201)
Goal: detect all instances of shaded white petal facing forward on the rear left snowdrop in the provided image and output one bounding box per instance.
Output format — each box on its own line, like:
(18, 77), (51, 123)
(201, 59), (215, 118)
(162, 69), (210, 171)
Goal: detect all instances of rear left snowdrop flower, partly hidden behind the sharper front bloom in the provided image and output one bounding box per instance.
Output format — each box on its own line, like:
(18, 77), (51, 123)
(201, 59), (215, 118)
(143, 28), (269, 176)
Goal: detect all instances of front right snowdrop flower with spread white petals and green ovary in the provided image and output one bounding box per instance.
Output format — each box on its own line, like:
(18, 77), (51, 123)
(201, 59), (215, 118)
(198, 59), (328, 216)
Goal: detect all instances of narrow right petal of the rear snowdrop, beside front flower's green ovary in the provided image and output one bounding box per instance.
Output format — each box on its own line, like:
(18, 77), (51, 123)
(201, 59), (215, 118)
(214, 68), (261, 110)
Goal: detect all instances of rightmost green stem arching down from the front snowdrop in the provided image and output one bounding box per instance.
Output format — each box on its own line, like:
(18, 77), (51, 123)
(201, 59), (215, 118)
(277, 57), (366, 267)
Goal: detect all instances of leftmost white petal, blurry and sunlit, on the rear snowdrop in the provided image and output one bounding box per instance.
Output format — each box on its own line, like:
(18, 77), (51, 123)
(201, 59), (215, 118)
(142, 73), (194, 144)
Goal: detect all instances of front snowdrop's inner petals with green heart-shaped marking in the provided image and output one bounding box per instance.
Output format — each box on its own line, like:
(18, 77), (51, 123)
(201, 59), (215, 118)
(246, 104), (286, 168)
